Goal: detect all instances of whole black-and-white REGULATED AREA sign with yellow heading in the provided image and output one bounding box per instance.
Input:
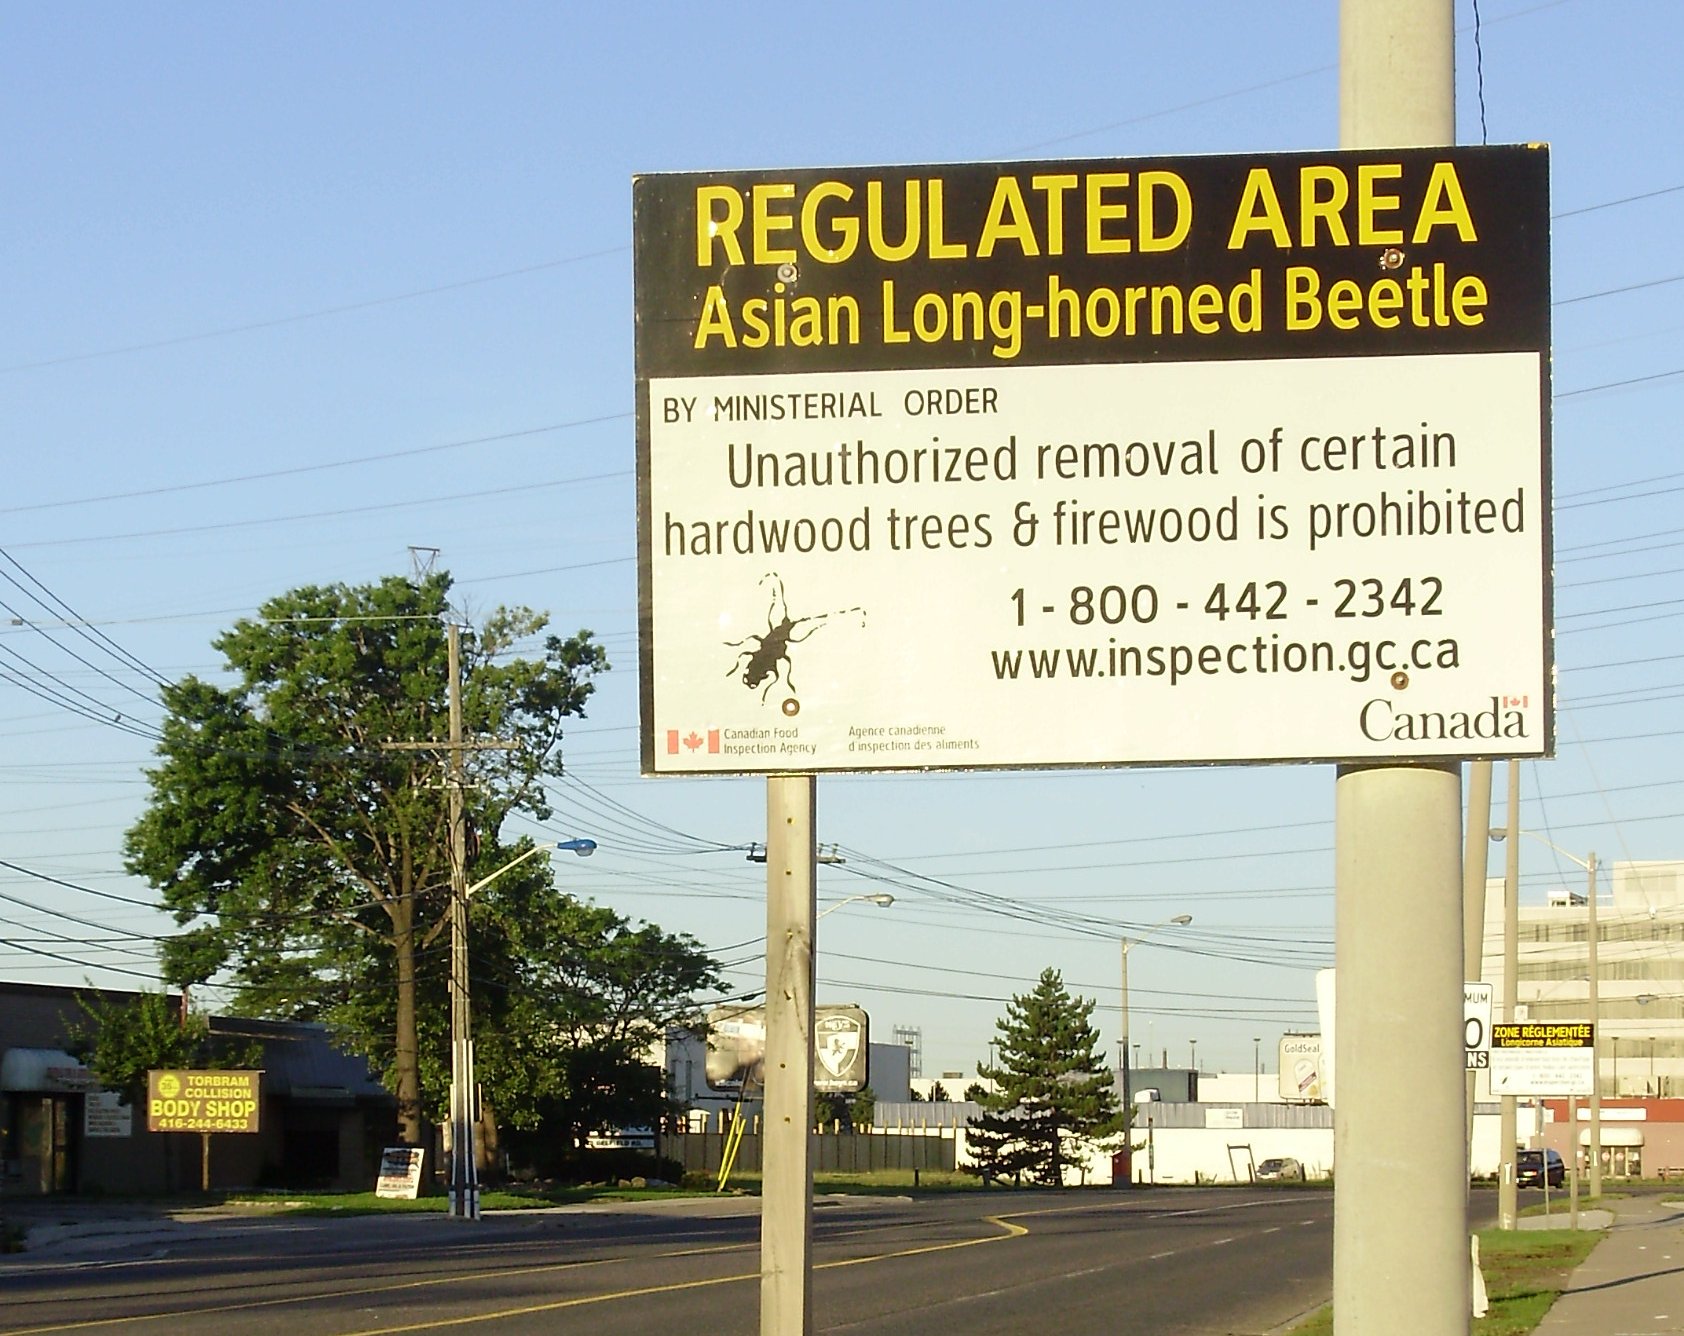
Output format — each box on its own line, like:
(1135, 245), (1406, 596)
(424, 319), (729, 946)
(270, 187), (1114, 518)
(633, 147), (1553, 775)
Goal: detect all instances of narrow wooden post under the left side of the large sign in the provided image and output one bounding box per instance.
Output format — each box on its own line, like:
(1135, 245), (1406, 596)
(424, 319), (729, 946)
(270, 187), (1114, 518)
(759, 775), (818, 1336)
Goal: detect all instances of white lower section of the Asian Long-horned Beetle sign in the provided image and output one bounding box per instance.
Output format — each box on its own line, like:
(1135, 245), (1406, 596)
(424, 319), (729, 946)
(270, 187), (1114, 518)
(650, 354), (1548, 772)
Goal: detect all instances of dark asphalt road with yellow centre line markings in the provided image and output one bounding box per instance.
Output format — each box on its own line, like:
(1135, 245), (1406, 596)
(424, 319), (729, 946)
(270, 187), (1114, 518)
(0, 1189), (1334, 1336)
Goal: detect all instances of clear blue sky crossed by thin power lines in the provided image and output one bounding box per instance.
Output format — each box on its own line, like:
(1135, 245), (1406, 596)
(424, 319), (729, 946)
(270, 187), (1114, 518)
(0, 0), (1684, 1075)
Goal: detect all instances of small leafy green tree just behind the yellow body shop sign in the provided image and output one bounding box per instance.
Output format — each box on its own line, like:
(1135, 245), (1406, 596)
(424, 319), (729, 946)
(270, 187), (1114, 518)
(71, 992), (263, 1104)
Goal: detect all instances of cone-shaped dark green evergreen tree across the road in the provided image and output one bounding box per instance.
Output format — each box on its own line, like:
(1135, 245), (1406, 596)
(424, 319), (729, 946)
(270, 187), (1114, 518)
(967, 969), (1128, 1188)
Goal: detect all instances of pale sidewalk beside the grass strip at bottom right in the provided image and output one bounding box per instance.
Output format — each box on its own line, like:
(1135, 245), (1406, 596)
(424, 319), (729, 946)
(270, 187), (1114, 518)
(1536, 1196), (1684, 1336)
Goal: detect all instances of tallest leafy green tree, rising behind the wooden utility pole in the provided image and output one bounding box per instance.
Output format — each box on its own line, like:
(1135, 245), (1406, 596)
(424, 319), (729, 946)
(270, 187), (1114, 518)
(125, 573), (608, 1142)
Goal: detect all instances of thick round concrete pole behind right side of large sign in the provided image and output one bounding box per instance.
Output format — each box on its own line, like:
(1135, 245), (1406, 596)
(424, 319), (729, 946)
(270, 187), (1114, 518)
(1334, 0), (1472, 1336)
